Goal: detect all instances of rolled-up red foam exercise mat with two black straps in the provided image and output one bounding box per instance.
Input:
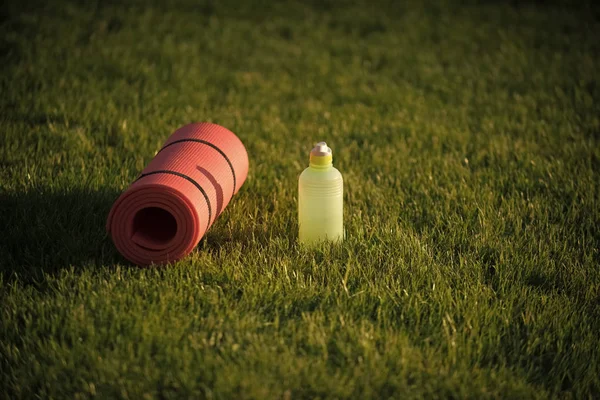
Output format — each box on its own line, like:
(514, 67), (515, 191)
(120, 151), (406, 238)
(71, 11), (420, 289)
(106, 123), (248, 265)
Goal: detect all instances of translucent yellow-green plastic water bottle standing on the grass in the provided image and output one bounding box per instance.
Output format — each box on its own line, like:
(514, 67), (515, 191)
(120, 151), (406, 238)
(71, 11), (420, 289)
(298, 142), (344, 244)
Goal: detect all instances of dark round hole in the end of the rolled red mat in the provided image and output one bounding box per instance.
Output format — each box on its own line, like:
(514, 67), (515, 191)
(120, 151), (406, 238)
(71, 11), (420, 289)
(133, 207), (177, 250)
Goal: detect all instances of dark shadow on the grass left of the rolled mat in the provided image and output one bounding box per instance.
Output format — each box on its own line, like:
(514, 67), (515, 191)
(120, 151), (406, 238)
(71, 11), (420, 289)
(0, 189), (122, 283)
